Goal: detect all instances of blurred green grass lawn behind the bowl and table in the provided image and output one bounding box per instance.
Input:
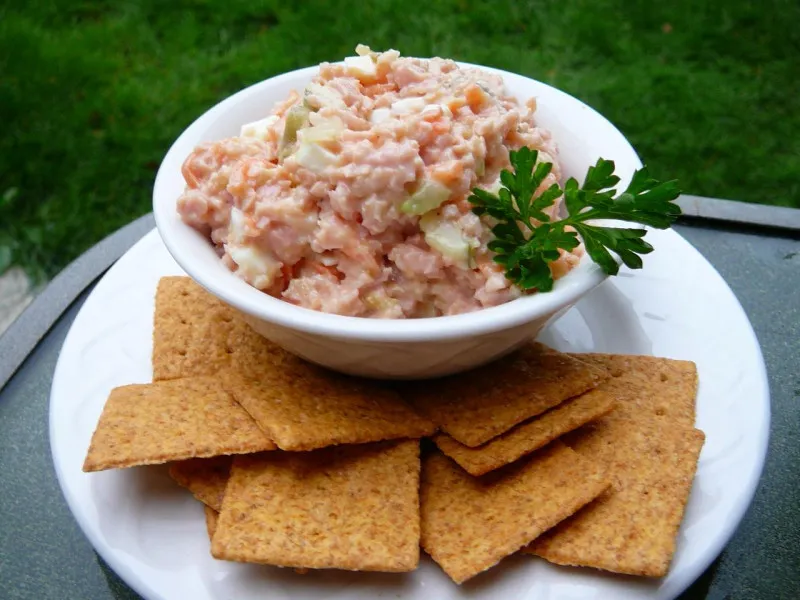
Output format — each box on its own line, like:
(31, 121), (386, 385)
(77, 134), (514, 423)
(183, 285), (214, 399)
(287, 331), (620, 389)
(0, 0), (800, 277)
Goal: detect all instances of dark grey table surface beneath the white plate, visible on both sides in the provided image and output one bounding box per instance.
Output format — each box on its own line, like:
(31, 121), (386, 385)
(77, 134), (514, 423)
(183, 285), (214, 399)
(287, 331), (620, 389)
(0, 216), (800, 600)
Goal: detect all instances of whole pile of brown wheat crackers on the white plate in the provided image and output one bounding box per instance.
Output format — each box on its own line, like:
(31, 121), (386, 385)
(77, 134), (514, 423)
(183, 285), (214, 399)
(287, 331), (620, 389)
(84, 277), (704, 583)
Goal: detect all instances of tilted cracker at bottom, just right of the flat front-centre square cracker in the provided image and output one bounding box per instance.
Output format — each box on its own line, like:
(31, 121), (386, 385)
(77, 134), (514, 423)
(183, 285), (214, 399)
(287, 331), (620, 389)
(420, 441), (608, 583)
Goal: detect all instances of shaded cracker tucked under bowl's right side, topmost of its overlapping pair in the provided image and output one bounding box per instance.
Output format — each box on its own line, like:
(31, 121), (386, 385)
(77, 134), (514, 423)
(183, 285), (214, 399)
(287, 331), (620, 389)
(406, 344), (608, 447)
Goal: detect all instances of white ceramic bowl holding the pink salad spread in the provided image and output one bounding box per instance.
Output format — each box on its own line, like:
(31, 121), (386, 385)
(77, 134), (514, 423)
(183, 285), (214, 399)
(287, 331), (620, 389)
(153, 62), (641, 379)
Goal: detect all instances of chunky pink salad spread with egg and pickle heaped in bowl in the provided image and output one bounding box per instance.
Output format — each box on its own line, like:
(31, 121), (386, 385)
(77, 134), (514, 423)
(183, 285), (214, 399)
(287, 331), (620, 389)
(178, 46), (579, 318)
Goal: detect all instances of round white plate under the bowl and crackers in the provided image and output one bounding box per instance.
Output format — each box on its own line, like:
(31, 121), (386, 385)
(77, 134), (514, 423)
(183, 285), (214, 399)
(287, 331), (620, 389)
(50, 231), (769, 600)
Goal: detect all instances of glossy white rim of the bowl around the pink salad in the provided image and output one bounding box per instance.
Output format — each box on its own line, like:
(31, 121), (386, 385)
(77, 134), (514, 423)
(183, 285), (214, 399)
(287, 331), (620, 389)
(153, 62), (642, 342)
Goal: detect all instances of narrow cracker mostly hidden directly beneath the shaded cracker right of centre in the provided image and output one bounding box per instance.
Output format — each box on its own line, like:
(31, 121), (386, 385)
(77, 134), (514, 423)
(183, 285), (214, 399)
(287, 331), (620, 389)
(433, 386), (614, 476)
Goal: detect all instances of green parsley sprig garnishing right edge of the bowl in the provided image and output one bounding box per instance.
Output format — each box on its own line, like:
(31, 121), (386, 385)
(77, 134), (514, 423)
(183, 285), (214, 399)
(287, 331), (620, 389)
(469, 147), (681, 292)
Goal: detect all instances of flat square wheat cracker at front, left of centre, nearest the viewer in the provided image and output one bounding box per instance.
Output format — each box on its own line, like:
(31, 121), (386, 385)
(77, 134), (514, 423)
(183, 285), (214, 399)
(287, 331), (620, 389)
(211, 440), (420, 572)
